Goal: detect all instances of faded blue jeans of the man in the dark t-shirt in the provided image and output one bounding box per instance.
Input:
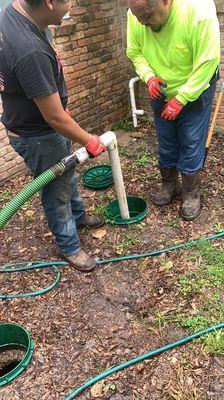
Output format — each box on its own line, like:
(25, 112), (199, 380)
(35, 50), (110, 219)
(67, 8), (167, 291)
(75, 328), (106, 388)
(9, 133), (85, 256)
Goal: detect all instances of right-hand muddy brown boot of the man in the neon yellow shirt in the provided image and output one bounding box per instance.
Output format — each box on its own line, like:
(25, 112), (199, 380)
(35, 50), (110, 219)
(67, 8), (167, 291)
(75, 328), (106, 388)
(181, 171), (201, 221)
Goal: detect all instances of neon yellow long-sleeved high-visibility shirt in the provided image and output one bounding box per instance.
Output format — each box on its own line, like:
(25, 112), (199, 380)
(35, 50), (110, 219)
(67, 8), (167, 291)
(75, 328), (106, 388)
(127, 0), (220, 104)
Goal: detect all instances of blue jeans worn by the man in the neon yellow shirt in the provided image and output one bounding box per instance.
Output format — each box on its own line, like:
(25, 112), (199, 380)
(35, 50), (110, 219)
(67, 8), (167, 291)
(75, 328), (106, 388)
(151, 82), (216, 174)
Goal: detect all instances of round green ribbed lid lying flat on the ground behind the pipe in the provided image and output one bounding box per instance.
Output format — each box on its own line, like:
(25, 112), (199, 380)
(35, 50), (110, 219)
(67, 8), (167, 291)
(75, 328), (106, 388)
(82, 165), (114, 189)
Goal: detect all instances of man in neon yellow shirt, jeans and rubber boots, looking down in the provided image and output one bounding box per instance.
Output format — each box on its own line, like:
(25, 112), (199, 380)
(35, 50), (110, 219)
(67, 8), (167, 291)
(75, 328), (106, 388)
(127, 0), (220, 220)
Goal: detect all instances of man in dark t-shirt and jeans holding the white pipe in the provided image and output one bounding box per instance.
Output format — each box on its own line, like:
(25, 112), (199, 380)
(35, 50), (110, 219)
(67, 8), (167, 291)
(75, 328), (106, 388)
(0, 0), (105, 272)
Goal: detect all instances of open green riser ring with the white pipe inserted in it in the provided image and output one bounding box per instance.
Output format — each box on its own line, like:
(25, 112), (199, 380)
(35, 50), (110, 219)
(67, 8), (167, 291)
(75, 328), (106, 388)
(104, 197), (148, 225)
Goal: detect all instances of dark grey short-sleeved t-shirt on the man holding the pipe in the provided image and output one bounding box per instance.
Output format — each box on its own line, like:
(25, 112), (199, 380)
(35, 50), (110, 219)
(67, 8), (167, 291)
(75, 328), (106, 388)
(0, 4), (68, 137)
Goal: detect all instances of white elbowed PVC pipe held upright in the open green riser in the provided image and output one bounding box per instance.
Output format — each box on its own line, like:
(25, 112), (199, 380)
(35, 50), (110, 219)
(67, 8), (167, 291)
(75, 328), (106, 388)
(75, 131), (130, 219)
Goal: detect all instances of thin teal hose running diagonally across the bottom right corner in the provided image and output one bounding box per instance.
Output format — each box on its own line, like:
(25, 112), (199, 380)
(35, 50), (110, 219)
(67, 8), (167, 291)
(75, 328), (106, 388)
(64, 322), (224, 400)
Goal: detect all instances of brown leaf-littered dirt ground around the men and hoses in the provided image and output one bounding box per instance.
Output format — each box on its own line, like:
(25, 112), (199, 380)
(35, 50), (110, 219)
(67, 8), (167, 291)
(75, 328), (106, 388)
(0, 124), (224, 400)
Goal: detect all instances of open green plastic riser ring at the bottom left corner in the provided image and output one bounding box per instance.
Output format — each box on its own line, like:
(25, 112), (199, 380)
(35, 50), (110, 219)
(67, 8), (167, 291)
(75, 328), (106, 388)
(0, 324), (34, 386)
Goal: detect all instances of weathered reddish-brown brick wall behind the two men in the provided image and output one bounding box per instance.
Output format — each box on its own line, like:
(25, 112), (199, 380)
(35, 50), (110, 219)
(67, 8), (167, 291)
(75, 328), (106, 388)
(0, 0), (224, 182)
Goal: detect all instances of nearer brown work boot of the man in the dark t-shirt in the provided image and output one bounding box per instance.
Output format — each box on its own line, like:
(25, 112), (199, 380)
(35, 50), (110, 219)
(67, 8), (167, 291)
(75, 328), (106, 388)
(61, 250), (96, 272)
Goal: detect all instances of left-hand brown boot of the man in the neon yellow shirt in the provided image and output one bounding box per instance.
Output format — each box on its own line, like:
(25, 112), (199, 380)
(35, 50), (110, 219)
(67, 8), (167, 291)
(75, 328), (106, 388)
(152, 167), (181, 206)
